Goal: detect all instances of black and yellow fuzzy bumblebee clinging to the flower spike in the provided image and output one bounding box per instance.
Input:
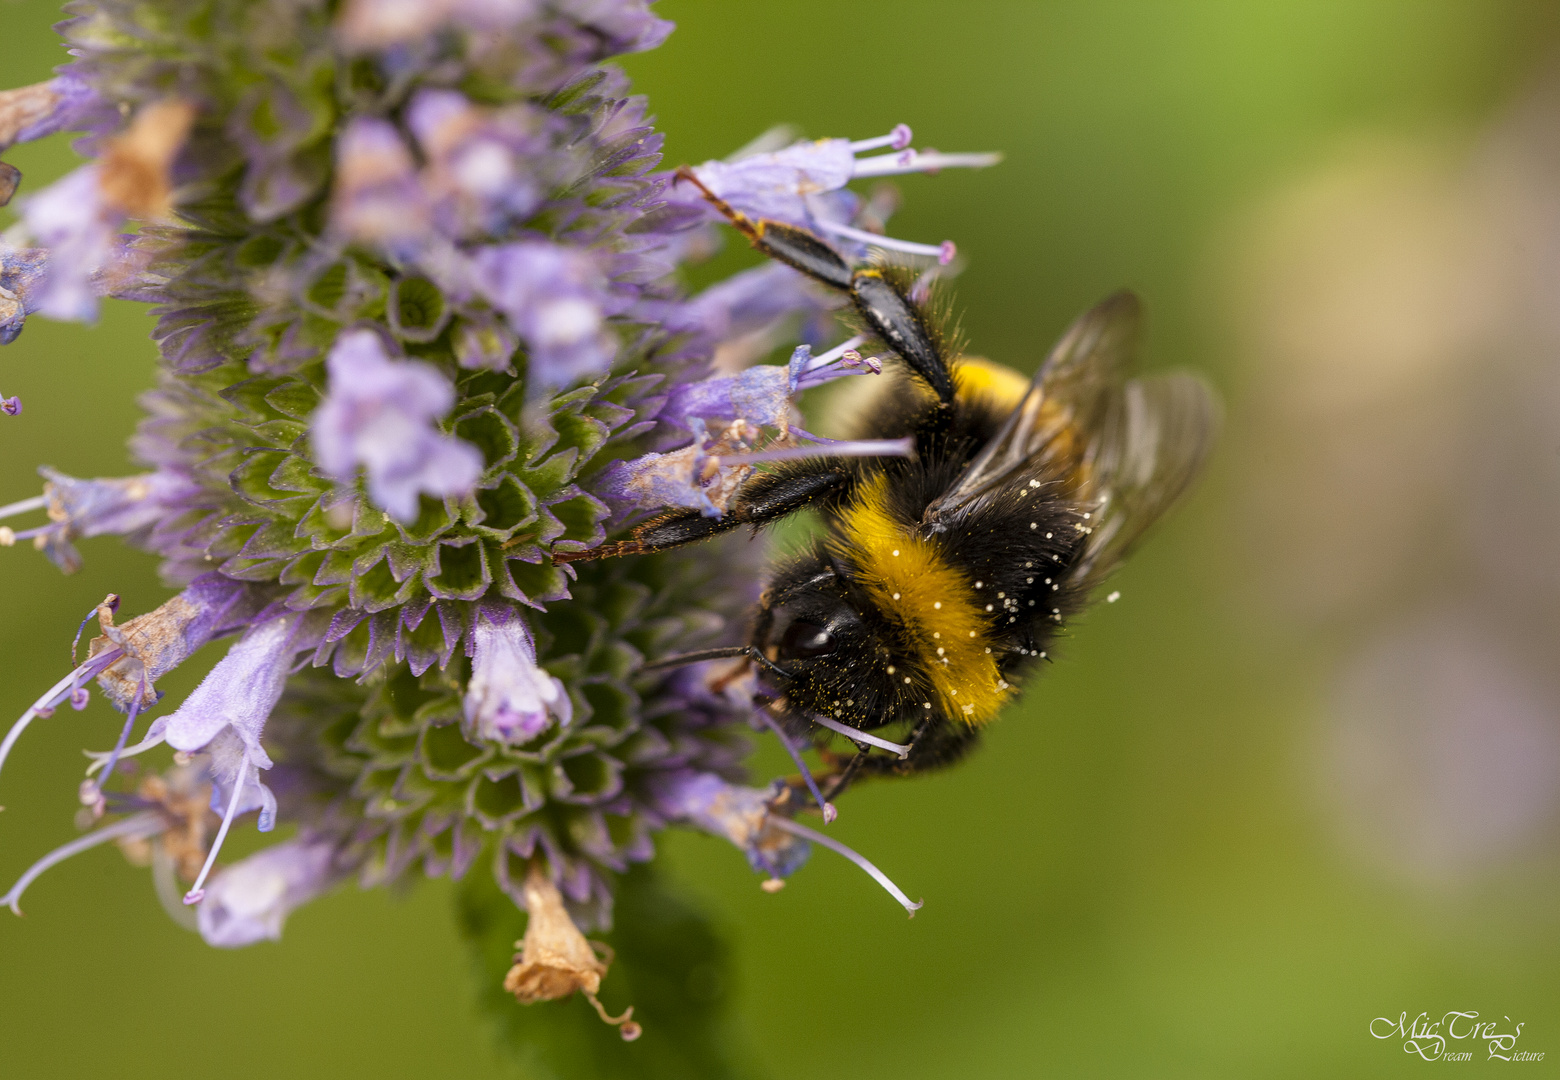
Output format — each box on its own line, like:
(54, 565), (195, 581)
(560, 169), (1218, 799)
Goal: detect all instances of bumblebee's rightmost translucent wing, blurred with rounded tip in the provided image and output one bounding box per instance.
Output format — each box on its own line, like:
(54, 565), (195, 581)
(1072, 371), (1218, 590)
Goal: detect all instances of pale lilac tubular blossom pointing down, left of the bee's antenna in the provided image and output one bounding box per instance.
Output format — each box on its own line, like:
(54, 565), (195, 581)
(465, 604), (574, 744)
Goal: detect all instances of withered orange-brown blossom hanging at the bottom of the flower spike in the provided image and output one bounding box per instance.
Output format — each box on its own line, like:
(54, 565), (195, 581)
(504, 860), (641, 1041)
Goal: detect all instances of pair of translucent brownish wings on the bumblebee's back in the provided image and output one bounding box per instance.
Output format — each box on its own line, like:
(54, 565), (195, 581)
(925, 292), (1218, 585)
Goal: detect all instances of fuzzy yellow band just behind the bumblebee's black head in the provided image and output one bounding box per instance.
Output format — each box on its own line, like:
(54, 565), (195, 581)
(835, 476), (1012, 724)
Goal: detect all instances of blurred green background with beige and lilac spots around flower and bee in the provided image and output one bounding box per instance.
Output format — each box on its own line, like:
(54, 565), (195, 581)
(0, 0), (1560, 1080)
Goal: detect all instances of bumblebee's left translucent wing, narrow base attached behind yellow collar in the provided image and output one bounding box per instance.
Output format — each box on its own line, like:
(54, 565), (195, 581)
(924, 292), (1142, 531)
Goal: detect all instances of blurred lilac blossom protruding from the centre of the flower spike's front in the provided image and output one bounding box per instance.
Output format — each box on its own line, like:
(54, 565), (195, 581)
(310, 329), (482, 521)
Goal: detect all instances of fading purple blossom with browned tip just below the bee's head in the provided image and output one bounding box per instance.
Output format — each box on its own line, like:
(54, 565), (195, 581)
(654, 769), (811, 877)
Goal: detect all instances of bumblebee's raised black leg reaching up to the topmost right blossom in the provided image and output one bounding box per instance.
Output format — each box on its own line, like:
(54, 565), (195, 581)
(677, 165), (953, 406)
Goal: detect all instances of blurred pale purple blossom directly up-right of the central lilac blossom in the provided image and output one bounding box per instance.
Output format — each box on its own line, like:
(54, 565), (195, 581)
(473, 240), (618, 393)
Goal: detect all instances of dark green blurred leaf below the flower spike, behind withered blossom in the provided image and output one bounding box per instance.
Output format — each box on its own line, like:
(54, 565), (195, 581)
(459, 866), (763, 1080)
